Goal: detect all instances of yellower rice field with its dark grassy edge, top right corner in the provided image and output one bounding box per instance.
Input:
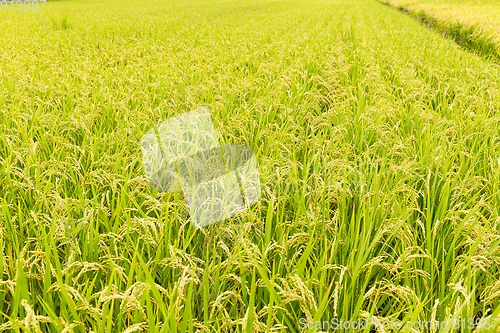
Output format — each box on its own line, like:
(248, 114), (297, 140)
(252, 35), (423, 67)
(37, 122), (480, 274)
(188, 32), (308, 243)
(380, 0), (500, 60)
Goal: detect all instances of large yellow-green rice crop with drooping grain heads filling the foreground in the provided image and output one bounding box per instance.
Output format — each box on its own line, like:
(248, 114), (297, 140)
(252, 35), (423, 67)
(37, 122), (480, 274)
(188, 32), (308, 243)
(0, 0), (500, 332)
